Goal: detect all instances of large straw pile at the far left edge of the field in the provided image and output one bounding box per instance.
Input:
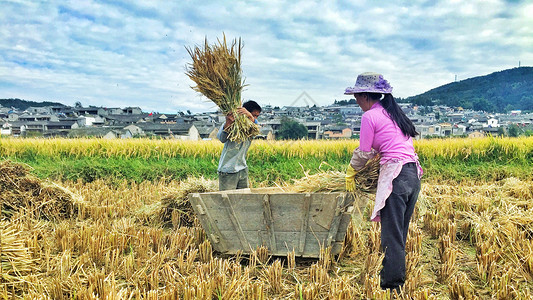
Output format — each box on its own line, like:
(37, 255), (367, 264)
(0, 160), (81, 220)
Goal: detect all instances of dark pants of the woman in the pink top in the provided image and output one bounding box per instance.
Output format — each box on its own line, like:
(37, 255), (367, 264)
(380, 163), (420, 290)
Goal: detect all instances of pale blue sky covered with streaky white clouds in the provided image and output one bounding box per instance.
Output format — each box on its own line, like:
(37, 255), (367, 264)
(0, 0), (533, 113)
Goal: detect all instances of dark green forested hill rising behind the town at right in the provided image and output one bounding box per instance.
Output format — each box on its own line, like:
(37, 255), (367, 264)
(404, 67), (533, 113)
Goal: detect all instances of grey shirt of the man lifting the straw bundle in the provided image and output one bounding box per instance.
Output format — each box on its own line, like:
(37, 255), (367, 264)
(217, 123), (252, 173)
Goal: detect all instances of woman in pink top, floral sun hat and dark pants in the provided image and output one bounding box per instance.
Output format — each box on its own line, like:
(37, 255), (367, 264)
(344, 73), (422, 291)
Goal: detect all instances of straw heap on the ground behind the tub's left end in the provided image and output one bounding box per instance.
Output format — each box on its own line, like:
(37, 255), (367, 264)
(159, 177), (218, 227)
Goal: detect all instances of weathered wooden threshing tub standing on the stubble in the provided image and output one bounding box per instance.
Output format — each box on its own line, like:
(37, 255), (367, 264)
(189, 188), (366, 257)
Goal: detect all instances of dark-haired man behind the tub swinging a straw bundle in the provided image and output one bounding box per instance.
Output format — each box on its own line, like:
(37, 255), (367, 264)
(217, 100), (261, 191)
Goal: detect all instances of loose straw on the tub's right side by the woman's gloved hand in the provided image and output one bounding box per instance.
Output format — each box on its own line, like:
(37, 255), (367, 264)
(291, 154), (381, 193)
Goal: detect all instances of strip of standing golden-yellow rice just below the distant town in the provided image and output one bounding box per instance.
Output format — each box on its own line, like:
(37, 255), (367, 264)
(0, 137), (533, 160)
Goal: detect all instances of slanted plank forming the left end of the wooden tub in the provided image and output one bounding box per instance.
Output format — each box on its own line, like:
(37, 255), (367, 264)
(189, 193), (228, 252)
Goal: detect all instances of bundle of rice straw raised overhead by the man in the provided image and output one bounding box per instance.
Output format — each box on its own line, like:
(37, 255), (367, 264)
(185, 35), (259, 142)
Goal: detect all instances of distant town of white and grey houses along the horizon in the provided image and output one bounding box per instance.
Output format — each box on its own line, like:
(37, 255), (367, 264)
(0, 99), (533, 140)
